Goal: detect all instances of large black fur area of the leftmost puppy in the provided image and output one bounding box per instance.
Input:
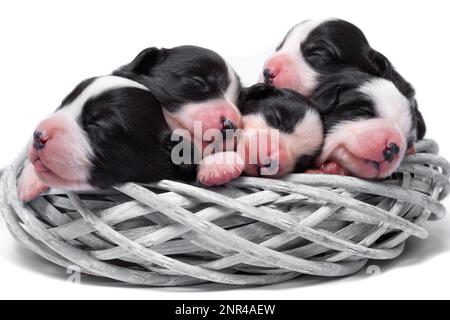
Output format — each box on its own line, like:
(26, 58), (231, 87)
(63, 79), (196, 188)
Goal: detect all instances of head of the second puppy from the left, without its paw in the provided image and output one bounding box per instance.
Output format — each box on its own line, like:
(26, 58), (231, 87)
(118, 46), (241, 139)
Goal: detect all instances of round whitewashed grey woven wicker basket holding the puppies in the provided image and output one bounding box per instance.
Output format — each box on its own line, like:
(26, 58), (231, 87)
(0, 140), (450, 286)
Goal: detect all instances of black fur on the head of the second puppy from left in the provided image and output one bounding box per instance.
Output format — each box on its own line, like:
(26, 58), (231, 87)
(115, 46), (240, 112)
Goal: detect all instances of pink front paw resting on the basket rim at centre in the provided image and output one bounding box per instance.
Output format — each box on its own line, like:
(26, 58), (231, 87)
(197, 152), (245, 187)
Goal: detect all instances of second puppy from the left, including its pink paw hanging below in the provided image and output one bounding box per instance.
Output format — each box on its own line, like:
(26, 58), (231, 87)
(115, 46), (246, 189)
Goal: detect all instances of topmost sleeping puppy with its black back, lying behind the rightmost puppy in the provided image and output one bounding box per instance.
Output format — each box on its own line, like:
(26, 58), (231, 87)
(260, 19), (426, 139)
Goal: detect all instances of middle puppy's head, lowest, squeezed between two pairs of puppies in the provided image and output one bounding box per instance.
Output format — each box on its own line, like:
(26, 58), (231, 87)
(238, 84), (323, 176)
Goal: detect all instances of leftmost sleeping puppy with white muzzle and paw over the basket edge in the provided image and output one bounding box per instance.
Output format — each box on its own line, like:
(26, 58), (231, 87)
(18, 76), (197, 201)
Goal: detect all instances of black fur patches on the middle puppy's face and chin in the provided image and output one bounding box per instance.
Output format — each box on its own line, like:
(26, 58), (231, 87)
(238, 84), (321, 172)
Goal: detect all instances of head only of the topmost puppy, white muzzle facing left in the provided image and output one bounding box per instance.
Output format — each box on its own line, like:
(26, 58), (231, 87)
(261, 19), (370, 96)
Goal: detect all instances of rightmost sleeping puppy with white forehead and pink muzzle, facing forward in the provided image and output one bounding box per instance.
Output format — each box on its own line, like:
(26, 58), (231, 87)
(312, 70), (417, 179)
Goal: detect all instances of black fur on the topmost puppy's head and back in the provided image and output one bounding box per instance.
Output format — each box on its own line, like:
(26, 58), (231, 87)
(279, 20), (426, 139)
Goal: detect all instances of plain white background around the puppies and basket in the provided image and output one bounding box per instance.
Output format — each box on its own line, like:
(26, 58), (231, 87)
(0, 0), (450, 299)
